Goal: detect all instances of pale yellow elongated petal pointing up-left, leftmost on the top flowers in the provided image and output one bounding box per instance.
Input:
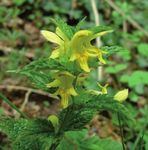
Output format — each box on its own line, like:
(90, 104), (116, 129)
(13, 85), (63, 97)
(41, 30), (63, 45)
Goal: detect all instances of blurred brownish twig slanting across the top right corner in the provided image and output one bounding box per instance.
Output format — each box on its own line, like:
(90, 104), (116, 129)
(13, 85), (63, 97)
(105, 0), (148, 37)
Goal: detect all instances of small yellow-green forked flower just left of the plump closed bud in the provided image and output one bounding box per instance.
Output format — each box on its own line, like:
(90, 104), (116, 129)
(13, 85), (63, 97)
(90, 83), (108, 95)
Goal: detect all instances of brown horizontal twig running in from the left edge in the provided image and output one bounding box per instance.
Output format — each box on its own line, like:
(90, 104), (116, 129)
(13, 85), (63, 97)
(0, 85), (58, 99)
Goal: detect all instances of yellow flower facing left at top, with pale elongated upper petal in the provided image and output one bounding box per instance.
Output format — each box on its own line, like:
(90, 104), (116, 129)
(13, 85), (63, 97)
(41, 28), (69, 59)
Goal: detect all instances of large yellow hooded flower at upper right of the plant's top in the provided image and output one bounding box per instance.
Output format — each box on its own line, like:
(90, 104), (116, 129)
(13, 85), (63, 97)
(70, 30), (111, 72)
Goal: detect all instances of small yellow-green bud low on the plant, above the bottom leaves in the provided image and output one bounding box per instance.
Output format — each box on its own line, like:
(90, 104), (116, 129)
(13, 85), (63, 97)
(48, 115), (59, 132)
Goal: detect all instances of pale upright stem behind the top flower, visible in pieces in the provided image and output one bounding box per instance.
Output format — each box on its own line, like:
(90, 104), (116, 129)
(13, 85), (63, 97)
(91, 0), (103, 81)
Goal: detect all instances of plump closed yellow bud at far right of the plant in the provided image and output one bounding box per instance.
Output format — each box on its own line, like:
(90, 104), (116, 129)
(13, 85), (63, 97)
(114, 89), (128, 103)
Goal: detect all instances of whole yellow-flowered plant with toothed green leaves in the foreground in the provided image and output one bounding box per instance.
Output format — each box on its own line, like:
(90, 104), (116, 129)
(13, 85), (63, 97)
(0, 18), (132, 150)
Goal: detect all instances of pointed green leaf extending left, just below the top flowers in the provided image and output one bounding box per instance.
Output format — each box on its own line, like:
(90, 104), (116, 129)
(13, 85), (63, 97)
(16, 58), (64, 91)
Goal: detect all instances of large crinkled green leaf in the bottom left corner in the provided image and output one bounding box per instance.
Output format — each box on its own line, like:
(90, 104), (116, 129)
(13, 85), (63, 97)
(0, 117), (54, 150)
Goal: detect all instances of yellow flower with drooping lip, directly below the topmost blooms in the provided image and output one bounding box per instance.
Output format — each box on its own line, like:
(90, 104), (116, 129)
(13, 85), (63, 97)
(47, 71), (77, 108)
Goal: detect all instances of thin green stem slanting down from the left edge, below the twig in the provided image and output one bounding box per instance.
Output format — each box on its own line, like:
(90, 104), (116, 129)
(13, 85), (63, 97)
(0, 93), (28, 118)
